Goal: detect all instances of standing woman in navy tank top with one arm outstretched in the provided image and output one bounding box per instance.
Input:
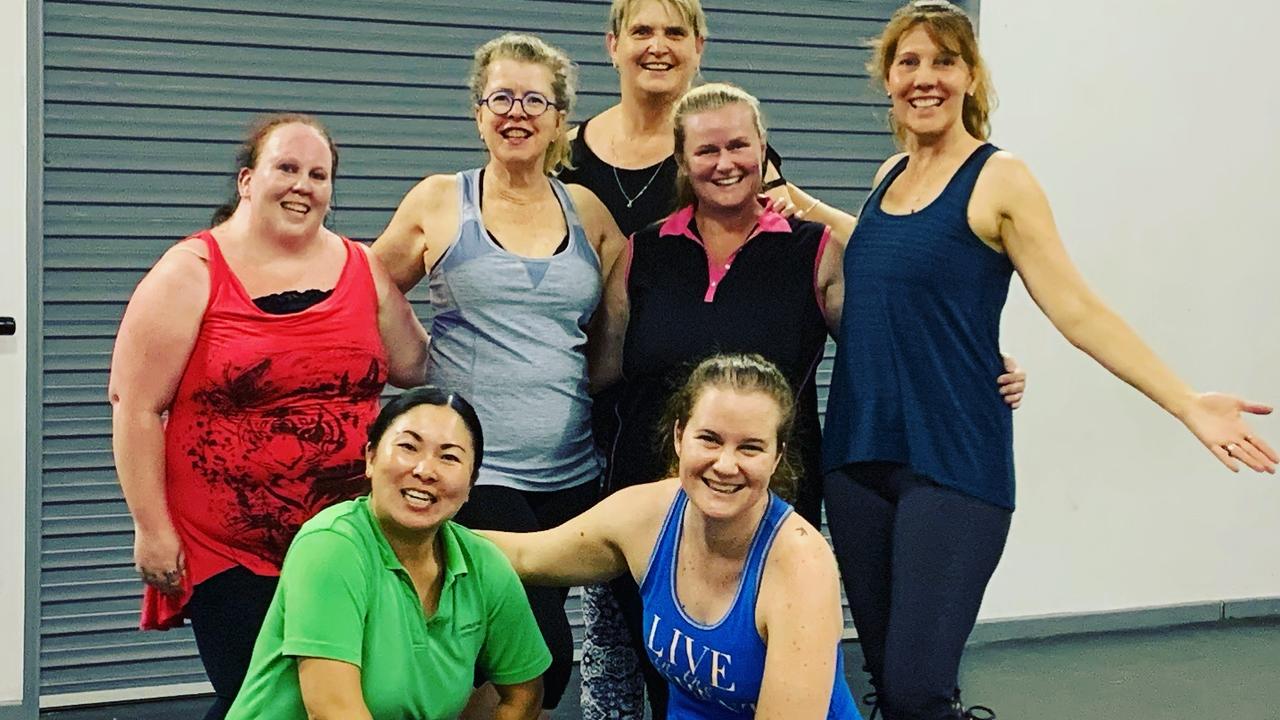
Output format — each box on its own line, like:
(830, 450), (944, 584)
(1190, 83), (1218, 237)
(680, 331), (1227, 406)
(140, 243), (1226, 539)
(823, 0), (1280, 720)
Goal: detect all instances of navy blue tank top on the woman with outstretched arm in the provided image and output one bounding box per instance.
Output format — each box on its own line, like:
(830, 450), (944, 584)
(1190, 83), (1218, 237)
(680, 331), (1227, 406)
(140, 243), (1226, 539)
(823, 145), (1014, 510)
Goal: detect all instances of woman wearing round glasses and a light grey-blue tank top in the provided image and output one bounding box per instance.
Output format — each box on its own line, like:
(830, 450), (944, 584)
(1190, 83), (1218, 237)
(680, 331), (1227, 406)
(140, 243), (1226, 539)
(374, 33), (623, 708)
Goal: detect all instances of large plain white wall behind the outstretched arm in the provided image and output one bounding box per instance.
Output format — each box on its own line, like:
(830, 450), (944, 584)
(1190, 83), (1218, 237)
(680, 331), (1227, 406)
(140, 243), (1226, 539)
(980, 0), (1280, 618)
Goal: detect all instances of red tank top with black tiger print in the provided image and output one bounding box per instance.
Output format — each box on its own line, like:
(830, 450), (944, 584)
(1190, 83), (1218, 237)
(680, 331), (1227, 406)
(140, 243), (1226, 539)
(142, 231), (387, 629)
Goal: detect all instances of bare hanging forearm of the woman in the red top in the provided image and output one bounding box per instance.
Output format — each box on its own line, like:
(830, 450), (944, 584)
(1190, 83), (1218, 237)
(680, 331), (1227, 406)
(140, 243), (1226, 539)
(111, 404), (173, 532)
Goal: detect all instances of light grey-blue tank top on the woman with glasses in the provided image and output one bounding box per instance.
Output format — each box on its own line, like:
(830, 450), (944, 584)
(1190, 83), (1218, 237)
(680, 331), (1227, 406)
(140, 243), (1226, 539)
(426, 169), (603, 491)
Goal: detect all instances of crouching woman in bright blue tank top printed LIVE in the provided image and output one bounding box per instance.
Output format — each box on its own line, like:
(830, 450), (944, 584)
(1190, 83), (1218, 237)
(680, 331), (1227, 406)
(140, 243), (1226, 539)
(484, 355), (859, 720)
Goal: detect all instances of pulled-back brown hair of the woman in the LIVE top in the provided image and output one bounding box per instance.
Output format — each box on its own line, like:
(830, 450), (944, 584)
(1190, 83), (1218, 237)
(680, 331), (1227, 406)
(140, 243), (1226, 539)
(659, 354), (800, 502)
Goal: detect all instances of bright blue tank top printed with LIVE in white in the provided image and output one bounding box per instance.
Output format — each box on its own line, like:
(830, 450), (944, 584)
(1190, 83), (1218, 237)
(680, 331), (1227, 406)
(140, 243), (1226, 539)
(640, 489), (861, 720)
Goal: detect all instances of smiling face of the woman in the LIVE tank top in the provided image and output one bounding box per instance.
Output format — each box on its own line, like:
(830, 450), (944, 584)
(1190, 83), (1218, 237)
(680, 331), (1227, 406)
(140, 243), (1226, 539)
(675, 386), (782, 519)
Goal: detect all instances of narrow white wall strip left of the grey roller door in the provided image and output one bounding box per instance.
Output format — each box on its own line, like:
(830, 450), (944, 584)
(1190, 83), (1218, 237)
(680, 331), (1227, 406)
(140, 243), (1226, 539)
(0, 0), (27, 705)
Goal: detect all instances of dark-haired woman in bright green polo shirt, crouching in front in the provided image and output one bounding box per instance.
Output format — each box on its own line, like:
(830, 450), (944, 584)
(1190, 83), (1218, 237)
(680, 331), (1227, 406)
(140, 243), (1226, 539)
(228, 387), (550, 720)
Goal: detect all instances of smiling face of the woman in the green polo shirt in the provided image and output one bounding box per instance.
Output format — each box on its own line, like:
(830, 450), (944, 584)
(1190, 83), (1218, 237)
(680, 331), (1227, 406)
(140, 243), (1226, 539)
(365, 405), (475, 536)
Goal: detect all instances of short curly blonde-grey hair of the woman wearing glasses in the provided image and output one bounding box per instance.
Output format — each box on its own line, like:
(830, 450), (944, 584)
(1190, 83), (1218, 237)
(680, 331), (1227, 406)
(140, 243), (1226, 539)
(467, 32), (577, 176)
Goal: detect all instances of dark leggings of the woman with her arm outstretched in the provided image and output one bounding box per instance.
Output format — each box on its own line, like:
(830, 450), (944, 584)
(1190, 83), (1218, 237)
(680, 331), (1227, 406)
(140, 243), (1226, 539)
(823, 462), (1012, 720)
